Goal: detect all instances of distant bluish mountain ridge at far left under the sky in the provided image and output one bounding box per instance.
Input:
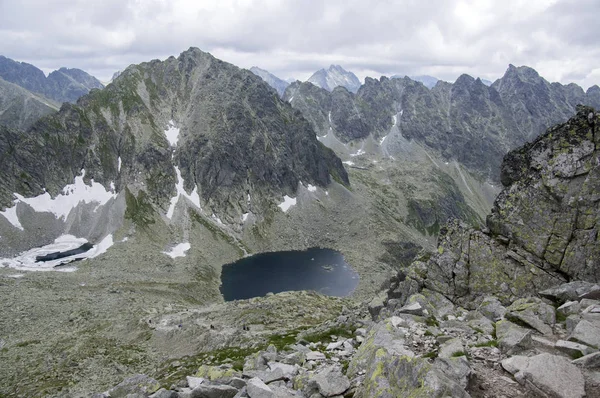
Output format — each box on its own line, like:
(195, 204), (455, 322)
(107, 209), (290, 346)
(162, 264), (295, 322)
(0, 55), (104, 102)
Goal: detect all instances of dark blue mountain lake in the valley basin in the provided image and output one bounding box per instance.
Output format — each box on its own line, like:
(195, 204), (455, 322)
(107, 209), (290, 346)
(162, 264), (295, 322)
(221, 248), (358, 301)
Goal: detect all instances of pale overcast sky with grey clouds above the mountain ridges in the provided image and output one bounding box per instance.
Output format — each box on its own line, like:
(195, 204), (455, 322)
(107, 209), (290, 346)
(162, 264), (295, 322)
(0, 0), (600, 88)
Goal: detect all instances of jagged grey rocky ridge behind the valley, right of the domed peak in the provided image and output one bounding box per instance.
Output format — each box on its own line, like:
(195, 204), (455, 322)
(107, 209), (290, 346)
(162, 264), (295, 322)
(284, 65), (600, 181)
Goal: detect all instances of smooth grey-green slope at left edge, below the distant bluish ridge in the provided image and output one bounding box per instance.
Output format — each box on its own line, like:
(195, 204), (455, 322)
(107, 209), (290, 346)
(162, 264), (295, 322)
(0, 79), (60, 130)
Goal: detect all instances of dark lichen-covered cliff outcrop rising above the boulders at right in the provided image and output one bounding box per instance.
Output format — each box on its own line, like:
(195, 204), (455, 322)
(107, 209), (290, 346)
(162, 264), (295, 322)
(398, 107), (600, 305)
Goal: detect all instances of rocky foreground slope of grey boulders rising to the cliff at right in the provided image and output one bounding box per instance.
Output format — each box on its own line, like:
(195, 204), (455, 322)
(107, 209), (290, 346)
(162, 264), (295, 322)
(89, 107), (600, 398)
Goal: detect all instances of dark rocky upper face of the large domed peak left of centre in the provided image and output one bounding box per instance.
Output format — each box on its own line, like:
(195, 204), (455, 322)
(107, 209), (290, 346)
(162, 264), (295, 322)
(0, 48), (348, 221)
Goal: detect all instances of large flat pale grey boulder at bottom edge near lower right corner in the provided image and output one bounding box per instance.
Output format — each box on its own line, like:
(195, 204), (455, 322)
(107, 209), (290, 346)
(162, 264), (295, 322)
(502, 353), (585, 398)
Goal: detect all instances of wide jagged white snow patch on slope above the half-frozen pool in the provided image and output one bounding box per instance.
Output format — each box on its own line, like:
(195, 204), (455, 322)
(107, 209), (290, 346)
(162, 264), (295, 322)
(0, 169), (117, 230)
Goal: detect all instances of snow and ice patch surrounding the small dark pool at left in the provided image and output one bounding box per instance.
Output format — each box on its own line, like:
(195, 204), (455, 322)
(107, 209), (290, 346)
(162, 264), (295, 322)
(0, 235), (114, 272)
